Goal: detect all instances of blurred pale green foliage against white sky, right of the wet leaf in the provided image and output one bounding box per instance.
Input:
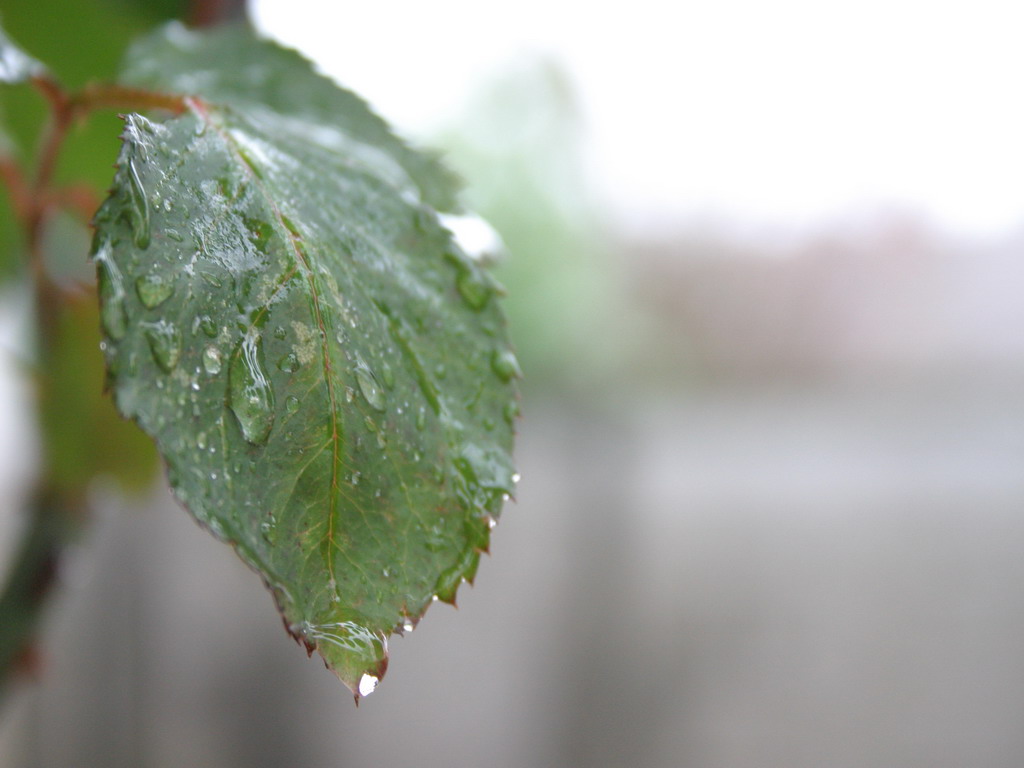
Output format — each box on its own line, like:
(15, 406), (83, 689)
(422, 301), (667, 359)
(437, 59), (629, 394)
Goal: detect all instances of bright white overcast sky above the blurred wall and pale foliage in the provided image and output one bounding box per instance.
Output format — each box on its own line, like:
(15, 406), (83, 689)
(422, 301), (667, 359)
(254, 0), (1024, 240)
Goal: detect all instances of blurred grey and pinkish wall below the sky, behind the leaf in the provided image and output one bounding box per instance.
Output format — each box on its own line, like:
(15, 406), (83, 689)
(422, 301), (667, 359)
(0, 214), (1024, 768)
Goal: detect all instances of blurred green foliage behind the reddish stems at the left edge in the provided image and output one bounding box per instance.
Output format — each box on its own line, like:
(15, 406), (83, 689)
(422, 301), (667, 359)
(0, 0), (187, 498)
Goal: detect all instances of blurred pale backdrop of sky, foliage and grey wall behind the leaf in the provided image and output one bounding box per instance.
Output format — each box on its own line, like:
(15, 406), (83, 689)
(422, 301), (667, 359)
(0, 0), (1024, 768)
